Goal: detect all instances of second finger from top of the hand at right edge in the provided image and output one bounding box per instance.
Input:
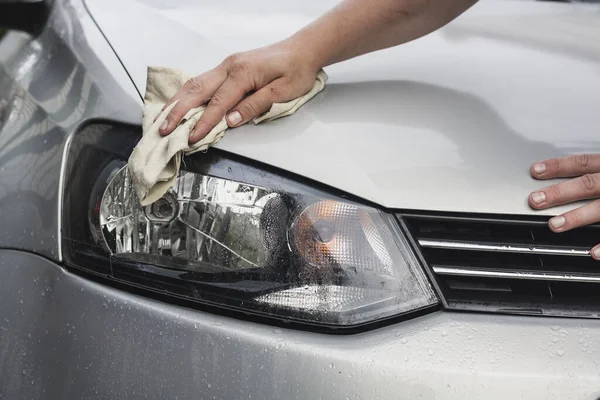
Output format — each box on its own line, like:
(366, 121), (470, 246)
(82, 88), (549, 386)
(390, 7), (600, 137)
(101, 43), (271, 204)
(529, 174), (600, 209)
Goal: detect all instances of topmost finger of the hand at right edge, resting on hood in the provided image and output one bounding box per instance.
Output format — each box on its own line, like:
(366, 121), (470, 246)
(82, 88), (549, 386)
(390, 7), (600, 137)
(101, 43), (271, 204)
(531, 154), (600, 179)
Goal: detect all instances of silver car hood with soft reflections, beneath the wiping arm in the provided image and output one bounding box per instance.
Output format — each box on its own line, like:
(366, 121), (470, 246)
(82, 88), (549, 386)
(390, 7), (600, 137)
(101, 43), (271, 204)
(86, 0), (600, 214)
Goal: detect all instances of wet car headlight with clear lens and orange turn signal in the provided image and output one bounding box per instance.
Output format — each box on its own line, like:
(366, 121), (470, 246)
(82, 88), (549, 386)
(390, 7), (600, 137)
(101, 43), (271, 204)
(62, 124), (437, 327)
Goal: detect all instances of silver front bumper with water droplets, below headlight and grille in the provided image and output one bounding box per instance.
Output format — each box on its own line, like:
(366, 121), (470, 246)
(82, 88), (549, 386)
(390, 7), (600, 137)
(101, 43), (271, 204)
(0, 250), (600, 400)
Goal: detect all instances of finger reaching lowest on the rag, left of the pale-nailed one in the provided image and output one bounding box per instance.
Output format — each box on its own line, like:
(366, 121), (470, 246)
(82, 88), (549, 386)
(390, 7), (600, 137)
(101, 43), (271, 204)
(190, 74), (253, 144)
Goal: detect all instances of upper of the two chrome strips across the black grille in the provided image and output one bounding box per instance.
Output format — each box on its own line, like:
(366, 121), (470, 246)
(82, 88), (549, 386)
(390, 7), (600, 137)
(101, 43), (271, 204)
(419, 239), (590, 257)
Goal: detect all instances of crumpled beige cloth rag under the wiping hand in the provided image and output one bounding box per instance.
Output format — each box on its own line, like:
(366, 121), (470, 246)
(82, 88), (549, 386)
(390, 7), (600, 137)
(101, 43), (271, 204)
(128, 67), (327, 206)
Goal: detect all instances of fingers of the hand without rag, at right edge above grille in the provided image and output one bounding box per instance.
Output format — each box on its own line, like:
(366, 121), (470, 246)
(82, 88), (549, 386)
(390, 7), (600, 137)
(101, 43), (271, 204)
(529, 154), (600, 260)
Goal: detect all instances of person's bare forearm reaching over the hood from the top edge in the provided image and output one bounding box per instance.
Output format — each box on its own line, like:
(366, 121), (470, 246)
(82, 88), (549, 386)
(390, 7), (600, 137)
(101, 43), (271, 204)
(286, 0), (477, 68)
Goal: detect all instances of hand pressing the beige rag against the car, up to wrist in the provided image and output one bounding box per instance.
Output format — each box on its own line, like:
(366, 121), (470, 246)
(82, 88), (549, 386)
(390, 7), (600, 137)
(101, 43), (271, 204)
(159, 42), (320, 144)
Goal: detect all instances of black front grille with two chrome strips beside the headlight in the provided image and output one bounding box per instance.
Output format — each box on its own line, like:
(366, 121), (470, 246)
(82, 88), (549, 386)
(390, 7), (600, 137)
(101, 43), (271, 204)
(399, 214), (600, 318)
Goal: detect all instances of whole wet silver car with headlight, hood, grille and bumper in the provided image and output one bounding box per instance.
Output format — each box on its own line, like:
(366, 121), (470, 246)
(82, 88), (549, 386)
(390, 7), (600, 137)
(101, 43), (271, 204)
(0, 0), (600, 400)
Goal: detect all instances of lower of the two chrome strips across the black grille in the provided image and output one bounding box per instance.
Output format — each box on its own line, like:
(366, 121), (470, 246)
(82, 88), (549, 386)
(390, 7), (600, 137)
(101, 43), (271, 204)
(432, 266), (600, 283)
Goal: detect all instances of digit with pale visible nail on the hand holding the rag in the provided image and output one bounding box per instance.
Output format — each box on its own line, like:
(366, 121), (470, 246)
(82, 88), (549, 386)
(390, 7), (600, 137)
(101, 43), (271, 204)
(227, 78), (293, 127)
